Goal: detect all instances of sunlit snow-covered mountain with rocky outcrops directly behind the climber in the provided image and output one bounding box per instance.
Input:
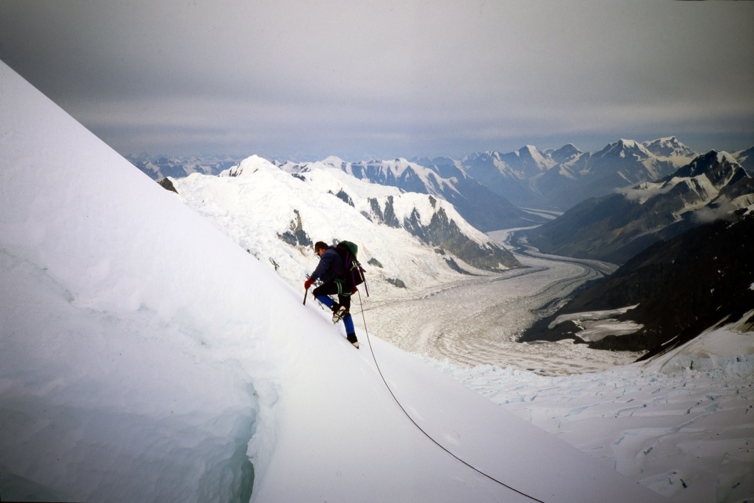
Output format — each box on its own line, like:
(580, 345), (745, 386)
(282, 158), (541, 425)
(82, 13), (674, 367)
(174, 156), (506, 298)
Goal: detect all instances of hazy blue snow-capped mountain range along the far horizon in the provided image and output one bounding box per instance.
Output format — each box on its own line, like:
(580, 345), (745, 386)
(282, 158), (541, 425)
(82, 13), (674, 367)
(132, 136), (754, 232)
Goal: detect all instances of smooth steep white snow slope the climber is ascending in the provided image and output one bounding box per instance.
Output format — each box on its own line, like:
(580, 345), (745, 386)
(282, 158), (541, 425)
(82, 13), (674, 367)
(0, 64), (662, 502)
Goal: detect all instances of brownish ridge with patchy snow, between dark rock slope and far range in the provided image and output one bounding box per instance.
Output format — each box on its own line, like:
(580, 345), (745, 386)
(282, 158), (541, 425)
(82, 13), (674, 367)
(524, 151), (754, 264)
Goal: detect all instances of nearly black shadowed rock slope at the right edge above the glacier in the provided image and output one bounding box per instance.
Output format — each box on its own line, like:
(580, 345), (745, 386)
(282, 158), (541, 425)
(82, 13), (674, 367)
(521, 210), (754, 357)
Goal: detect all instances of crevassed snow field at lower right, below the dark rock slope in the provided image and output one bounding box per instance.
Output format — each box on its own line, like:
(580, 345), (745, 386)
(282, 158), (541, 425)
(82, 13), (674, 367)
(424, 318), (754, 503)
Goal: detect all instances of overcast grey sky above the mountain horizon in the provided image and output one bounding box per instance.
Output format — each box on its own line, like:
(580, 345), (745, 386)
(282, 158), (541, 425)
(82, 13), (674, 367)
(0, 0), (754, 160)
